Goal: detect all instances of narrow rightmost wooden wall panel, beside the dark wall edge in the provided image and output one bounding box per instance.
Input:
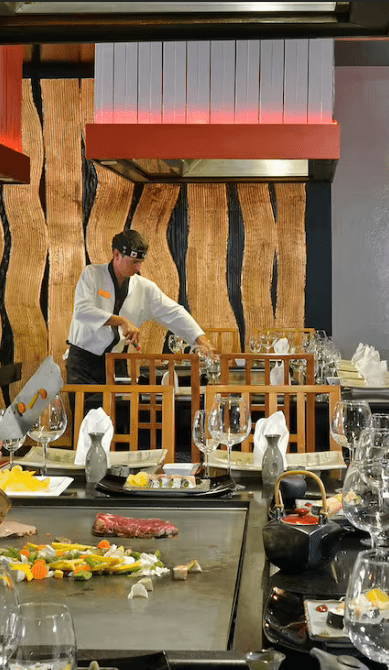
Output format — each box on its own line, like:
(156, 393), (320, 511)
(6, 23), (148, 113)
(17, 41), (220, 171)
(275, 184), (307, 328)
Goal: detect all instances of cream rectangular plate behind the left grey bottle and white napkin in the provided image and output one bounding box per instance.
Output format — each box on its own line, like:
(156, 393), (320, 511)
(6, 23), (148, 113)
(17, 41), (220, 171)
(15, 447), (167, 471)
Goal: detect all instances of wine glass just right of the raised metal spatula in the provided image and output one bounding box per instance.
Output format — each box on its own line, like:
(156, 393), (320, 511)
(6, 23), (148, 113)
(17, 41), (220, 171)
(27, 394), (68, 475)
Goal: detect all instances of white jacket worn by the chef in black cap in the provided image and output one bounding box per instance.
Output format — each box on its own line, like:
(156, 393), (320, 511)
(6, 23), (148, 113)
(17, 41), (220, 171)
(68, 263), (204, 356)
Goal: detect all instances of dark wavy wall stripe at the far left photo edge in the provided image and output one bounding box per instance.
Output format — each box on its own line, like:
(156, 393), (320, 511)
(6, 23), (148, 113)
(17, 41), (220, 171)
(0, 185), (14, 365)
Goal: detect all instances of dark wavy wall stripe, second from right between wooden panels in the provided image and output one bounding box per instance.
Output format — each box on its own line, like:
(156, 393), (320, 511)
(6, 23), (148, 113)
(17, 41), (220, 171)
(227, 183), (246, 351)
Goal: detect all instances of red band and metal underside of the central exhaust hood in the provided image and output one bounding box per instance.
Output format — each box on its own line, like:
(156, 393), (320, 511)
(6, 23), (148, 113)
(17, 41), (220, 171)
(86, 124), (340, 183)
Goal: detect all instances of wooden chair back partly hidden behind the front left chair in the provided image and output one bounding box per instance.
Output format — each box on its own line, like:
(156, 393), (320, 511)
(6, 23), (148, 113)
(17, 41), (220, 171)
(105, 353), (200, 463)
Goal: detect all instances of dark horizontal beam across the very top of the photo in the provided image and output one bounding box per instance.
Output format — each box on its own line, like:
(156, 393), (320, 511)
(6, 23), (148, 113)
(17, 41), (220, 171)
(0, 2), (389, 44)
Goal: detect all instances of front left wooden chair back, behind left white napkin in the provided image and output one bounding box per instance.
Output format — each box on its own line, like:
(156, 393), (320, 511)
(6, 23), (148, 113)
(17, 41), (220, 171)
(62, 384), (175, 463)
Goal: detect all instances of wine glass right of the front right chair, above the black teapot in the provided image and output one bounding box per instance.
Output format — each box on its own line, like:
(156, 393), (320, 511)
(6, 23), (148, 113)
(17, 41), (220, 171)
(331, 400), (371, 460)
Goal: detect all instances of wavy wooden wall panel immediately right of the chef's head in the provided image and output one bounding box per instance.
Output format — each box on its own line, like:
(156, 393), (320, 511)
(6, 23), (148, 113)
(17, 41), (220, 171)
(132, 184), (180, 353)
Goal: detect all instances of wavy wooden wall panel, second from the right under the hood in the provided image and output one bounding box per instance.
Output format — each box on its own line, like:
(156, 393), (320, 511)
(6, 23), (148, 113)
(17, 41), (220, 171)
(238, 184), (277, 351)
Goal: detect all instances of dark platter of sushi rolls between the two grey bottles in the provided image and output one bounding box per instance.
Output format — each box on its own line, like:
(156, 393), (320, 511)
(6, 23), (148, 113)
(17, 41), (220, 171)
(96, 473), (234, 498)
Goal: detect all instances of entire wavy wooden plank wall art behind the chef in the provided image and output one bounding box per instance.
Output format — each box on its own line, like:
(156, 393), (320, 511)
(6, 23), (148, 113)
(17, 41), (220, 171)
(0, 79), (313, 444)
